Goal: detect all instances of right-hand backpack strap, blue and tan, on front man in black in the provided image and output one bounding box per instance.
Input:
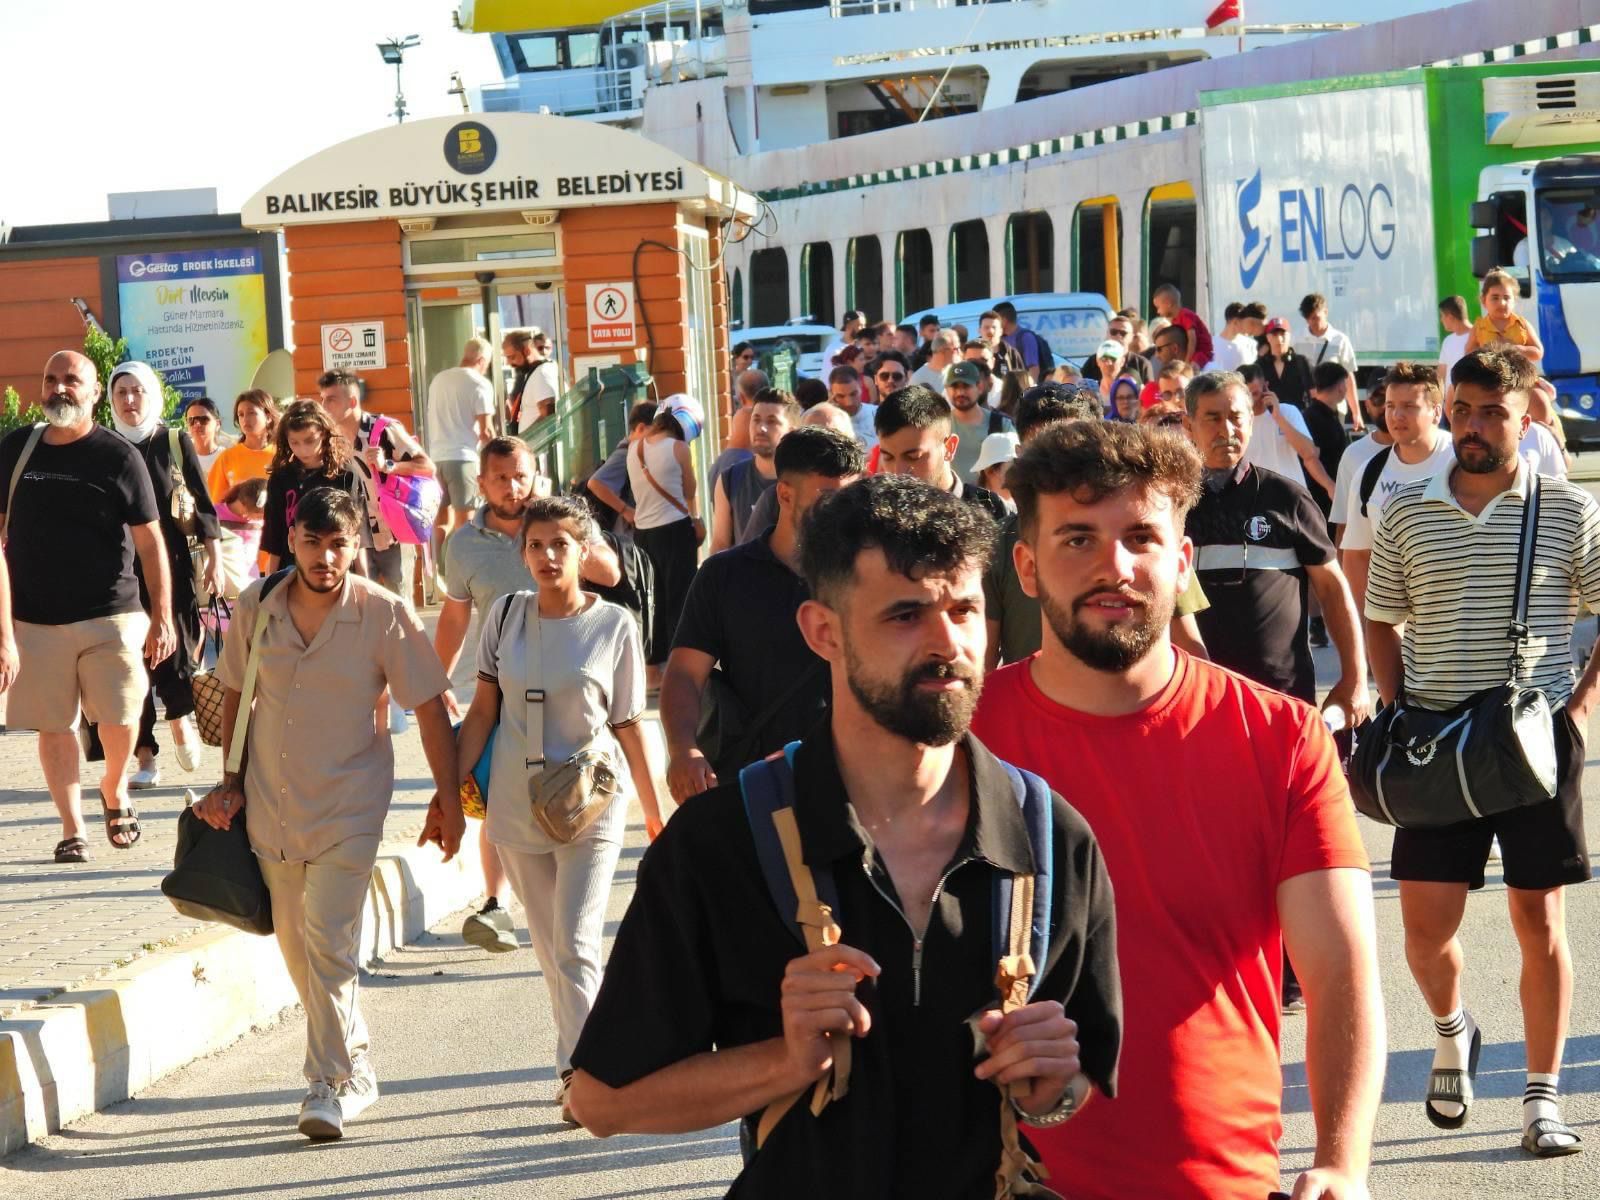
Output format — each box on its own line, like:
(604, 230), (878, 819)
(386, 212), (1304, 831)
(992, 760), (1056, 1200)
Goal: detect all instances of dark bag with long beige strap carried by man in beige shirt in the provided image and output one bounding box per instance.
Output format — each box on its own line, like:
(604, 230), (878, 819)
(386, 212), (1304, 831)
(162, 568), (293, 936)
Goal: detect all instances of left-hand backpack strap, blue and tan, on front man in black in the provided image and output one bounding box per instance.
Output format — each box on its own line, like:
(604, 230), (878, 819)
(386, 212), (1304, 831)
(739, 742), (850, 1149)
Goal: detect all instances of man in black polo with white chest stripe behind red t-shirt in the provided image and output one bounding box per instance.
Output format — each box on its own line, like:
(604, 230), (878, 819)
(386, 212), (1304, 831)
(1184, 371), (1371, 723)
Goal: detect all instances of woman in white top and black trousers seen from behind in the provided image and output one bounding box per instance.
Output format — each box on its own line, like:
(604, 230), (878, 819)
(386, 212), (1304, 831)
(627, 395), (706, 683)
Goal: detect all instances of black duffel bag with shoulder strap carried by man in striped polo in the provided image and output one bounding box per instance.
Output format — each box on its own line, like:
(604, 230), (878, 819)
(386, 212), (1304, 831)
(1350, 470), (1560, 829)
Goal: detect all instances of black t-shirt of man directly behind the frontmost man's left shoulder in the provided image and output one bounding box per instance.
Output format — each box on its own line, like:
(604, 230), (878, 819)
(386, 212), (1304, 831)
(672, 530), (830, 762)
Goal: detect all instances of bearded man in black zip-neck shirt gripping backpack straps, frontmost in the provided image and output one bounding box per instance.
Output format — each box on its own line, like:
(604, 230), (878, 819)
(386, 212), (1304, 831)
(570, 475), (1122, 1200)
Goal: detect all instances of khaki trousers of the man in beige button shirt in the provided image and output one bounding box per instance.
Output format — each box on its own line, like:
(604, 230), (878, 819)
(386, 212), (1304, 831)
(258, 837), (378, 1088)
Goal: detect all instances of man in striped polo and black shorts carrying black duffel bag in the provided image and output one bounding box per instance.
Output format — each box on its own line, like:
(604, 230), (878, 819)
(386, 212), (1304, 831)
(1352, 350), (1600, 1158)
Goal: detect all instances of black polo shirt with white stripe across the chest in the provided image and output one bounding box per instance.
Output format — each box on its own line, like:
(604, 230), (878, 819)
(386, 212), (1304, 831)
(1184, 462), (1334, 704)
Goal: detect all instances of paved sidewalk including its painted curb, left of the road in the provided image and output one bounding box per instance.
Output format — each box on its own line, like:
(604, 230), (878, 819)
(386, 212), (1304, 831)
(0, 613), (666, 1157)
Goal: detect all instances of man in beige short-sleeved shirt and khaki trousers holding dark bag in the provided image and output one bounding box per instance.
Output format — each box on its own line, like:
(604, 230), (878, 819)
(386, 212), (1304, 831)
(195, 488), (466, 1138)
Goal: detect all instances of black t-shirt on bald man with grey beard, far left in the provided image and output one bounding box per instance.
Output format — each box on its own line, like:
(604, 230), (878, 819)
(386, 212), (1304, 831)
(0, 426), (157, 626)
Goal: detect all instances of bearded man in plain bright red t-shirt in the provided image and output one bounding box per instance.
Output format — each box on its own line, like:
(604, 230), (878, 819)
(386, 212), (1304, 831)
(973, 421), (1384, 1200)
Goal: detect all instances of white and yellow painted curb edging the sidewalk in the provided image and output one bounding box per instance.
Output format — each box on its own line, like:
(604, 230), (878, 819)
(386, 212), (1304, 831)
(0, 829), (483, 1158)
